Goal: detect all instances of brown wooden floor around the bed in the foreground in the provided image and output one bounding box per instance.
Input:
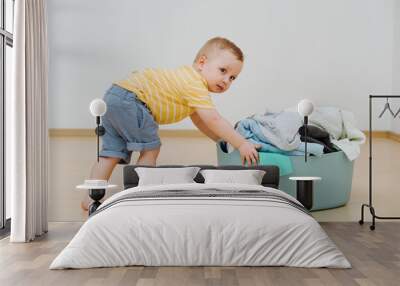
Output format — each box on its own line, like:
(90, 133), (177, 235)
(0, 222), (400, 286)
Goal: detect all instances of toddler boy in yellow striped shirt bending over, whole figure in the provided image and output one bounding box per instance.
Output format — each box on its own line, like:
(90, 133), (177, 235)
(82, 37), (258, 209)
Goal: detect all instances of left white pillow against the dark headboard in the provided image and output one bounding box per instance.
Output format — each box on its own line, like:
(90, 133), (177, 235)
(135, 167), (200, 186)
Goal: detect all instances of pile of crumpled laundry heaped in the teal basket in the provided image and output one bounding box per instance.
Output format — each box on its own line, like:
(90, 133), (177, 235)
(225, 107), (365, 161)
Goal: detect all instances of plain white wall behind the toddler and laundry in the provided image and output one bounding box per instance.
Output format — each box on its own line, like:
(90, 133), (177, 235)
(48, 0), (398, 129)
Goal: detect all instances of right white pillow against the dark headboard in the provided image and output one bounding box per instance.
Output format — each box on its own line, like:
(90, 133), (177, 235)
(200, 169), (265, 185)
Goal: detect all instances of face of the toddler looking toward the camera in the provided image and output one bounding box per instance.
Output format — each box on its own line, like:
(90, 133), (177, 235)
(195, 49), (243, 93)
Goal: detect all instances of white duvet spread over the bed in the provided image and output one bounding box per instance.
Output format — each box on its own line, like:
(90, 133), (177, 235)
(50, 183), (351, 269)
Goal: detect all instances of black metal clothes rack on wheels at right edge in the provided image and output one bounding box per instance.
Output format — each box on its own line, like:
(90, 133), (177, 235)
(358, 95), (400, 230)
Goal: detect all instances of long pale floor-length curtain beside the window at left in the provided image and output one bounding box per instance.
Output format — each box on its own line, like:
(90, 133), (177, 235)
(6, 0), (49, 242)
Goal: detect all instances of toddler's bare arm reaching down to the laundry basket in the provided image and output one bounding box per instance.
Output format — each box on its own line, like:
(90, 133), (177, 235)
(196, 108), (259, 165)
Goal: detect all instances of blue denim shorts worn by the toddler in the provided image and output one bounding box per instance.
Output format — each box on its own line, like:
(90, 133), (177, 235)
(100, 85), (161, 164)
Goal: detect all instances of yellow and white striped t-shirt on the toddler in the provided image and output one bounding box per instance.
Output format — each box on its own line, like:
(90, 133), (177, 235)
(115, 66), (215, 124)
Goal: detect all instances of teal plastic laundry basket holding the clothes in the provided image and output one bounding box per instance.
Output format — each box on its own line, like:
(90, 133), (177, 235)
(217, 144), (354, 210)
